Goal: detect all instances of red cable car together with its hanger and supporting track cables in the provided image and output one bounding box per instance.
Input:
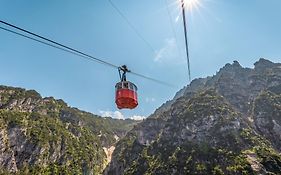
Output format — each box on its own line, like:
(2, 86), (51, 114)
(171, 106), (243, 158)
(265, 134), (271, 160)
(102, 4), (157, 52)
(0, 20), (174, 109)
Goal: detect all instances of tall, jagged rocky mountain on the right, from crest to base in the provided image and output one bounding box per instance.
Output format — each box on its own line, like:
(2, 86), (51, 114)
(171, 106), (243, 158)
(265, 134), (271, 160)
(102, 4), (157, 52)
(104, 58), (281, 175)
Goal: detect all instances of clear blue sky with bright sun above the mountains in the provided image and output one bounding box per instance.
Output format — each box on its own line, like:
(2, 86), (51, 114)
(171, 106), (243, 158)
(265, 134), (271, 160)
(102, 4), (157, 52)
(0, 0), (281, 118)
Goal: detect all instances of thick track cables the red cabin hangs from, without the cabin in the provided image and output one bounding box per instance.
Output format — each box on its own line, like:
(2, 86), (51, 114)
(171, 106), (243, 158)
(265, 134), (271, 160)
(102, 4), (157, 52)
(0, 20), (175, 87)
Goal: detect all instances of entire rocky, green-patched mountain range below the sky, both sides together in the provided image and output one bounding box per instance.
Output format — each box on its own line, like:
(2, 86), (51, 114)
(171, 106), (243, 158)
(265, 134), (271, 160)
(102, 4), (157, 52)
(0, 59), (281, 175)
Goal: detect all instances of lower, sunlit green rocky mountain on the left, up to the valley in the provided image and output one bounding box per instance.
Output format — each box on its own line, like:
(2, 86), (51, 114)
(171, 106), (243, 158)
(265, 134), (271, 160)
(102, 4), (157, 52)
(0, 86), (137, 174)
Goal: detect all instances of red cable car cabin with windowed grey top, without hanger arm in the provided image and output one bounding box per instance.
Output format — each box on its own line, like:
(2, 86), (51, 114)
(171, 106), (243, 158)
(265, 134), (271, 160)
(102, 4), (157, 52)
(115, 81), (138, 109)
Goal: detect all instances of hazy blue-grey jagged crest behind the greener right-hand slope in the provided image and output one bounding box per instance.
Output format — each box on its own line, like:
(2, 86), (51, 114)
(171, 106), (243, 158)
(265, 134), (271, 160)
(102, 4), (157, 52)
(151, 58), (281, 117)
